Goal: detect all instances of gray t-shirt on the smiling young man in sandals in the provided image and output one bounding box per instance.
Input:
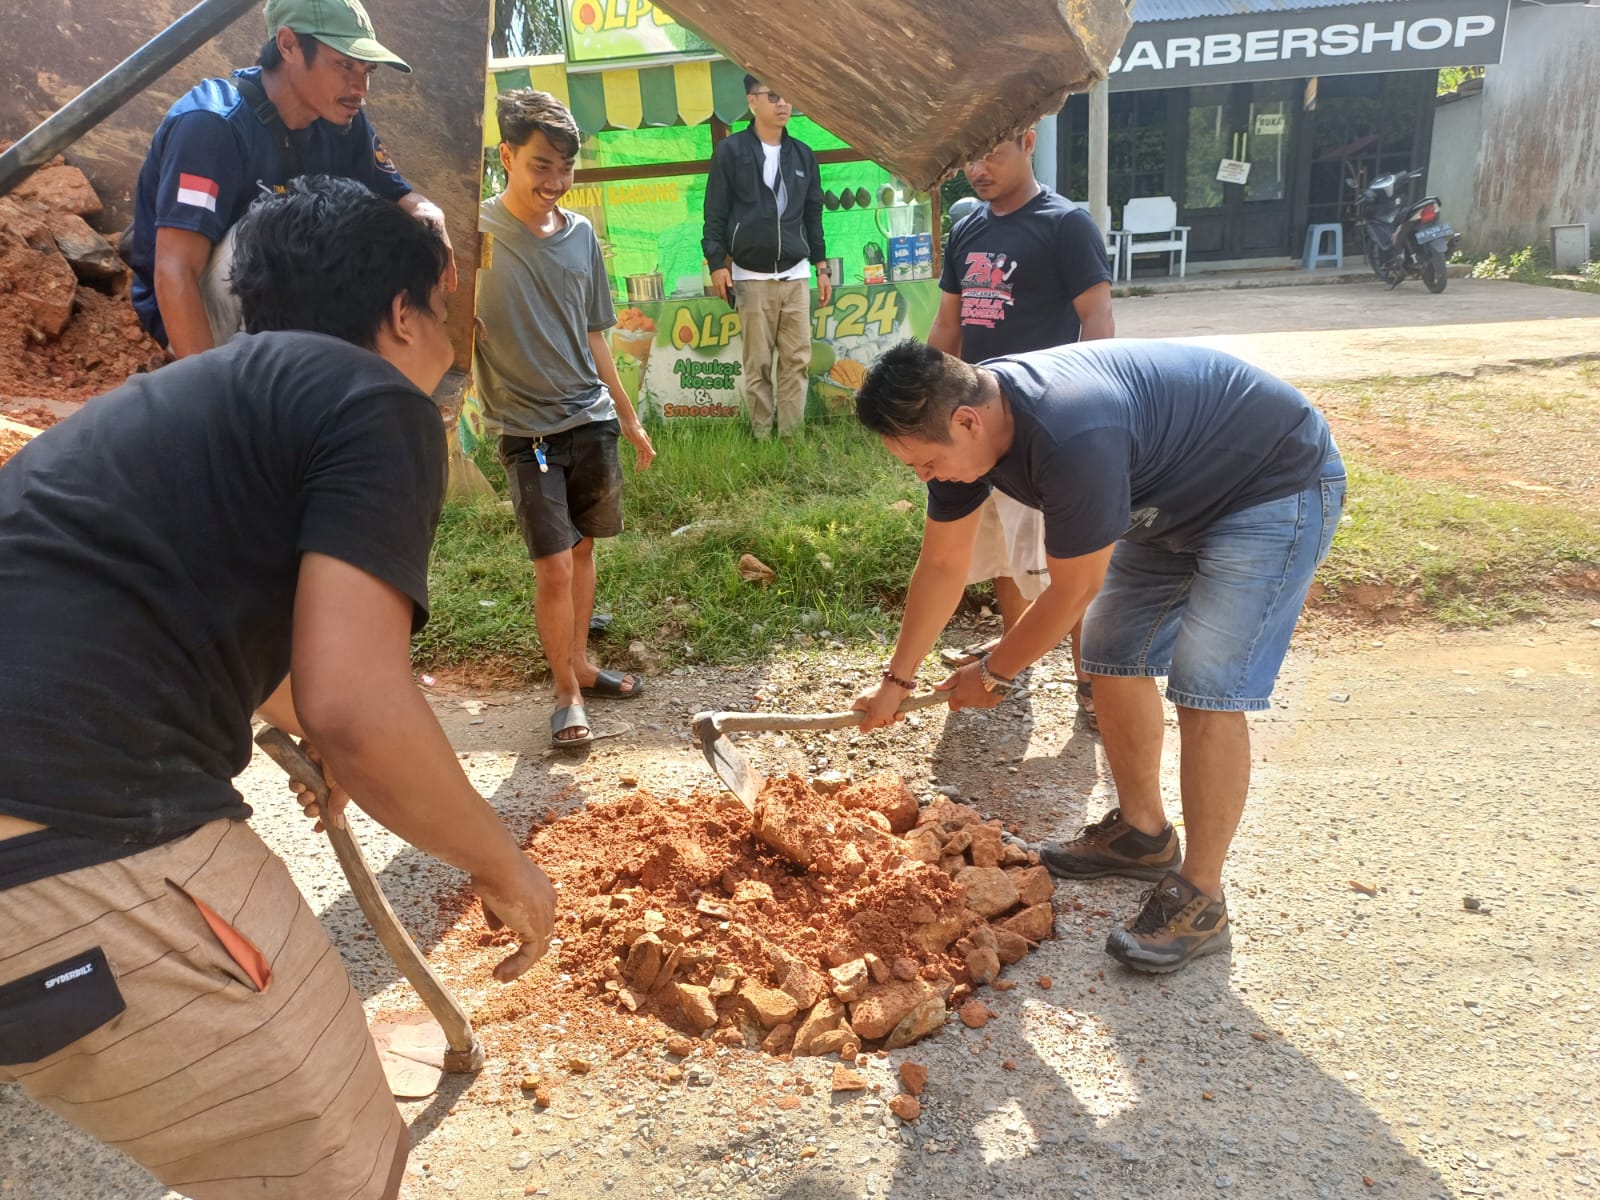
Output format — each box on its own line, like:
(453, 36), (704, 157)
(472, 197), (616, 437)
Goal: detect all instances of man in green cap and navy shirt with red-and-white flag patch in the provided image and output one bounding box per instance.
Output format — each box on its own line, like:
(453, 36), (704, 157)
(123, 0), (456, 358)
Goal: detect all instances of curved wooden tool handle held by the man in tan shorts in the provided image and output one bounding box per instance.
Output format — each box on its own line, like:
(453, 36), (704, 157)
(256, 725), (483, 1074)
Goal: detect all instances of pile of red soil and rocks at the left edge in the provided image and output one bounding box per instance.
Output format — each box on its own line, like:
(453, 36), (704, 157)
(0, 158), (163, 418)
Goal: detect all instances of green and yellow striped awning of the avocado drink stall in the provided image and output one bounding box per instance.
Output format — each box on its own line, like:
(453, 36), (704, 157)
(483, 59), (747, 146)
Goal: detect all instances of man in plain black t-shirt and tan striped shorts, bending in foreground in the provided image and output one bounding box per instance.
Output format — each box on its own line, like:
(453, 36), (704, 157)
(0, 179), (554, 1200)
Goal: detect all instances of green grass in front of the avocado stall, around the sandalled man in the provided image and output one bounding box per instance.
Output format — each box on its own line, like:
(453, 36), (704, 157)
(414, 421), (923, 664)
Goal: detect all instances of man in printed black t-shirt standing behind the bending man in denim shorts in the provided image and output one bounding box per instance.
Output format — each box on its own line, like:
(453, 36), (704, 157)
(928, 130), (1115, 728)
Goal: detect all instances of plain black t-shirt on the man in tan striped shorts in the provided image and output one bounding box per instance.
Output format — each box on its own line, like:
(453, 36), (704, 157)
(0, 333), (445, 845)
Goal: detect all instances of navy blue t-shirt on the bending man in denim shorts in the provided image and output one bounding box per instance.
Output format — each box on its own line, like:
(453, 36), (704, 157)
(928, 339), (1333, 558)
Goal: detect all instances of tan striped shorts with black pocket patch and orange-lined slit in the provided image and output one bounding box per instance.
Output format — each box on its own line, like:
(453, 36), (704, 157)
(0, 821), (406, 1200)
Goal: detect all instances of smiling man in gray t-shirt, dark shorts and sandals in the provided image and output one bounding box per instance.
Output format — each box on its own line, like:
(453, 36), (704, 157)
(472, 88), (656, 749)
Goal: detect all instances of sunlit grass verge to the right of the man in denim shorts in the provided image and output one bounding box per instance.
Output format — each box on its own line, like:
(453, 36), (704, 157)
(1320, 462), (1600, 626)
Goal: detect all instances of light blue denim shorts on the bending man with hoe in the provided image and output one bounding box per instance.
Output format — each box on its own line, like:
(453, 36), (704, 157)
(1082, 450), (1344, 712)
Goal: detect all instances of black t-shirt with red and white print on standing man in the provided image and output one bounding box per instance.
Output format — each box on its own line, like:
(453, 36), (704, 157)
(939, 187), (1110, 363)
